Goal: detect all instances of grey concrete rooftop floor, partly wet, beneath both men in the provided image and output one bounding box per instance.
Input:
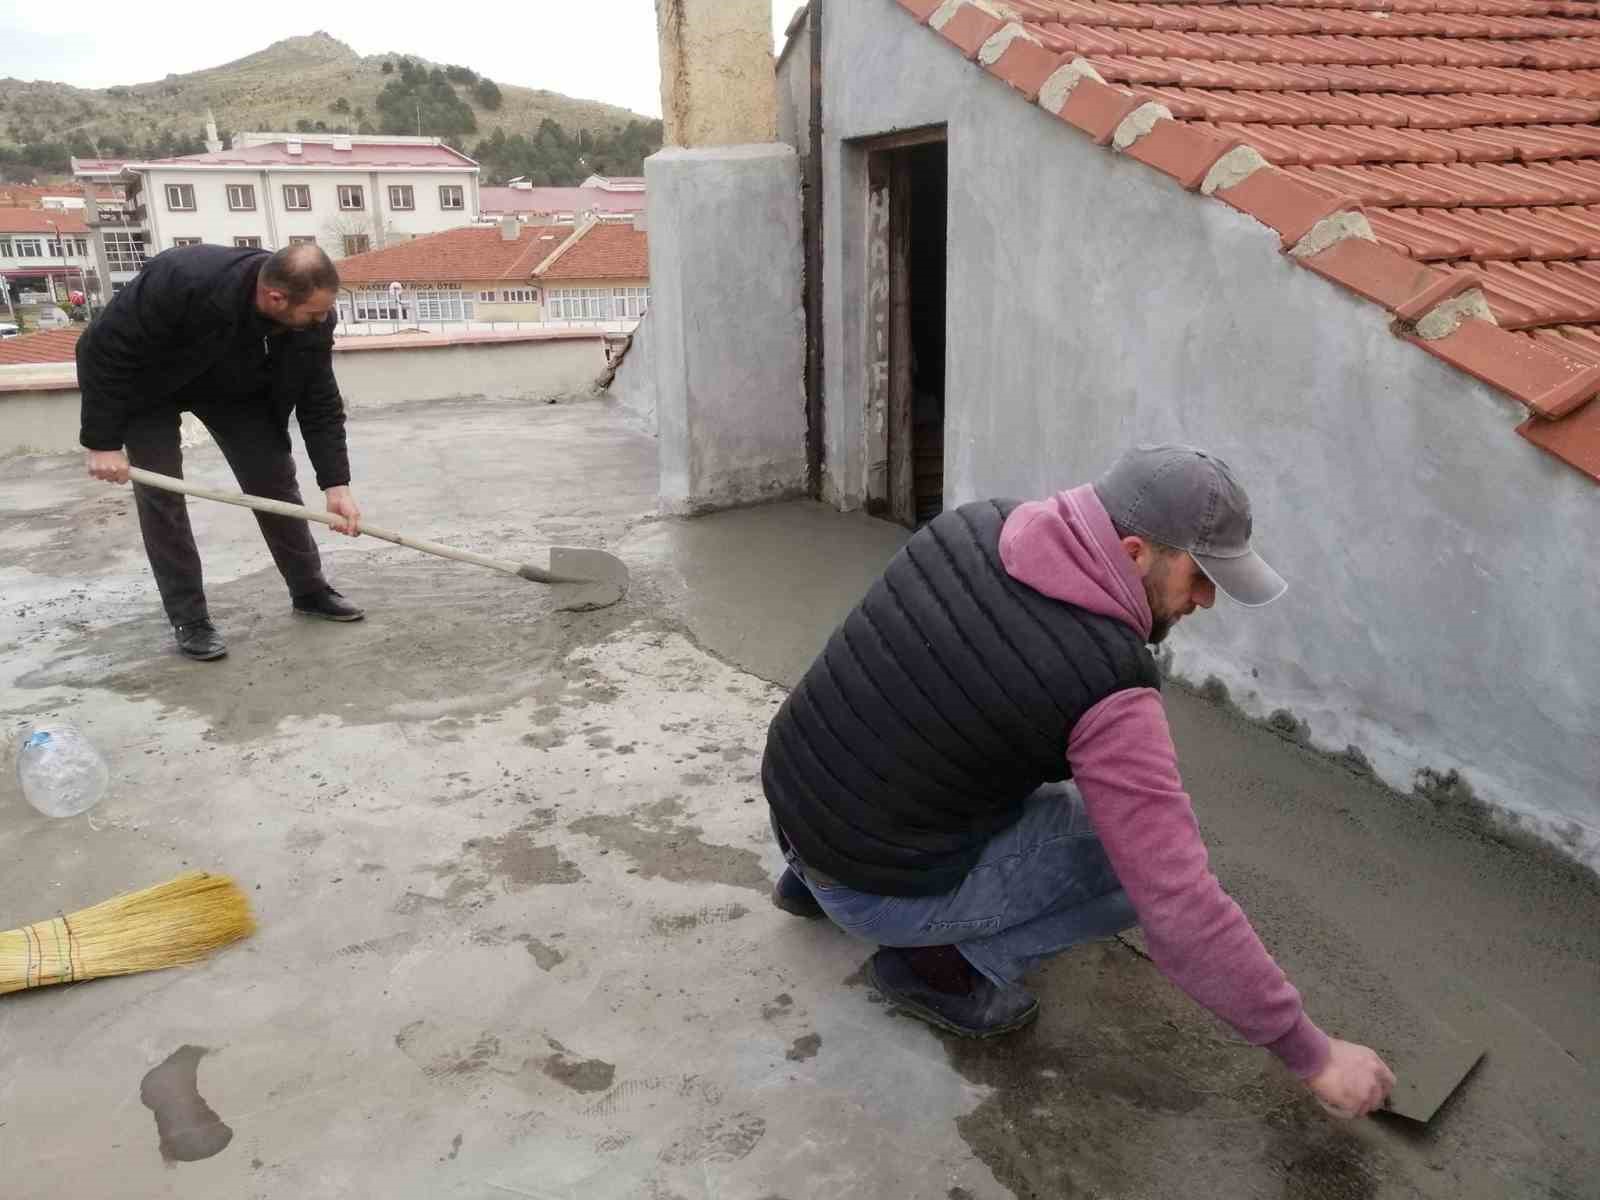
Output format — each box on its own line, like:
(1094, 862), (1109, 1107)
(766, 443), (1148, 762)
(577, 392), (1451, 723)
(0, 392), (1600, 1200)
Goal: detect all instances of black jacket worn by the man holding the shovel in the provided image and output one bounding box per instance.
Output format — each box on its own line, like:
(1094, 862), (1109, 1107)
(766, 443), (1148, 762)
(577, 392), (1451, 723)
(77, 246), (350, 490)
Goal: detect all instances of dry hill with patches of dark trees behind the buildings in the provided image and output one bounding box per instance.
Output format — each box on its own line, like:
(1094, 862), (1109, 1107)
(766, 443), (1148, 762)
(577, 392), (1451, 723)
(0, 32), (659, 176)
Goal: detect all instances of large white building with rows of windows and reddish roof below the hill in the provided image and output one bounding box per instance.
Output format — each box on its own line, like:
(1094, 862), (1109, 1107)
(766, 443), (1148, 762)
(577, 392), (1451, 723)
(80, 125), (478, 258)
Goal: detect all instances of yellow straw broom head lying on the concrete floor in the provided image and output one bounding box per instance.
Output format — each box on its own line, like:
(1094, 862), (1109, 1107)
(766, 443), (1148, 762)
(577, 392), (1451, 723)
(0, 870), (256, 995)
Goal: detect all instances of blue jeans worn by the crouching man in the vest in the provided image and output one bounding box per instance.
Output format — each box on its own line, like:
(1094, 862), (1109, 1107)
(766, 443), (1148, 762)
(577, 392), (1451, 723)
(786, 782), (1139, 987)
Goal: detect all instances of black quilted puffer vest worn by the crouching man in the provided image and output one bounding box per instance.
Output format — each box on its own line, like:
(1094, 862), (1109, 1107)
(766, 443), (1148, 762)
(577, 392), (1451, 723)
(762, 501), (1160, 896)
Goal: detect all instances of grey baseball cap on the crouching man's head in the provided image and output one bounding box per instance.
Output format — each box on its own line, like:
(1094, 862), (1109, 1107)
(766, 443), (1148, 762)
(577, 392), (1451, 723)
(1094, 445), (1290, 608)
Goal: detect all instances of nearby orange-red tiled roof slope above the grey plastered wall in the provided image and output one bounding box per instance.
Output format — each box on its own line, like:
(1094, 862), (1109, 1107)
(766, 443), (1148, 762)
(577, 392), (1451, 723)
(898, 0), (1600, 482)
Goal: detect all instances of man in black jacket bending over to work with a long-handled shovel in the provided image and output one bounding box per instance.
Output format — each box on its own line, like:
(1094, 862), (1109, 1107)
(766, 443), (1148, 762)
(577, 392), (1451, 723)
(77, 245), (363, 659)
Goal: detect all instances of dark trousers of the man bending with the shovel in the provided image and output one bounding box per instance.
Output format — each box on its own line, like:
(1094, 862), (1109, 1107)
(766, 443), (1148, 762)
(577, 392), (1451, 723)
(123, 402), (326, 626)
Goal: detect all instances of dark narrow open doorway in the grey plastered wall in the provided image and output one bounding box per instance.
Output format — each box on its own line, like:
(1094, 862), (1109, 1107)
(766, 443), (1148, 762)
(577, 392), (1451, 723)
(867, 130), (949, 528)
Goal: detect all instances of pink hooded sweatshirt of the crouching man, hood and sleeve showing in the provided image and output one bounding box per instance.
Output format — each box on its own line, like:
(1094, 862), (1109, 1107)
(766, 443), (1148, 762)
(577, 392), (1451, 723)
(1000, 485), (1328, 1078)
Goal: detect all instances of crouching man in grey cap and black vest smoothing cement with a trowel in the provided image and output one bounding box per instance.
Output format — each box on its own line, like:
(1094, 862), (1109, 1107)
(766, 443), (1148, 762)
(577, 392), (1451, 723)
(762, 446), (1394, 1117)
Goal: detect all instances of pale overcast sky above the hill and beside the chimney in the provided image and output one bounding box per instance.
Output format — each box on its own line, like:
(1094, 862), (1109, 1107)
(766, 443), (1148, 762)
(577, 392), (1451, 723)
(0, 0), (800, 117)
